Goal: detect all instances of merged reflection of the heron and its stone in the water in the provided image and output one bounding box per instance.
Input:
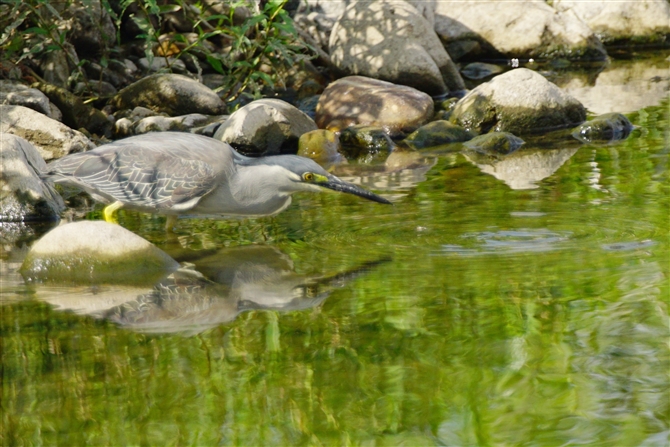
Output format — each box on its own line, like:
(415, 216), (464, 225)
(36, 246), (384, 335)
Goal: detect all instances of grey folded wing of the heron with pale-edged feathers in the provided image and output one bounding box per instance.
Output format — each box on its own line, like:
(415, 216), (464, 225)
(49, 146), (217, 210)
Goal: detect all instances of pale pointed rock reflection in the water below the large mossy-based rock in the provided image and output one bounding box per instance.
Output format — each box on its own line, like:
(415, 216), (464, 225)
(463, 148), (578, 189)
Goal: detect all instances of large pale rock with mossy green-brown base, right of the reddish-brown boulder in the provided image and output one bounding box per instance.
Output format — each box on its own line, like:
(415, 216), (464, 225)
(451, 68), (586, 134)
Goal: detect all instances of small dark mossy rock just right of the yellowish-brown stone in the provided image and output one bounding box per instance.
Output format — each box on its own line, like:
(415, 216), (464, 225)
(340, 125), (393, 163)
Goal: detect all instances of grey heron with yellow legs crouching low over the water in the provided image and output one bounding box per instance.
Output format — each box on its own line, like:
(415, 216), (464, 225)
(41, 132), (391, 231)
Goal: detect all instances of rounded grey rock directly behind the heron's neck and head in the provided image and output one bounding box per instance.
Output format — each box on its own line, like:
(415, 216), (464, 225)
(214, 98), (317, 155)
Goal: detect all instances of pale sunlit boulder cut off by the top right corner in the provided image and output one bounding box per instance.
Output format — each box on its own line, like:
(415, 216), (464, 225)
(553, 0), (670, 44)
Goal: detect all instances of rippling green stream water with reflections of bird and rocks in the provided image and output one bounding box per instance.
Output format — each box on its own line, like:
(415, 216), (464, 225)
(0, 57), (670, 446)
